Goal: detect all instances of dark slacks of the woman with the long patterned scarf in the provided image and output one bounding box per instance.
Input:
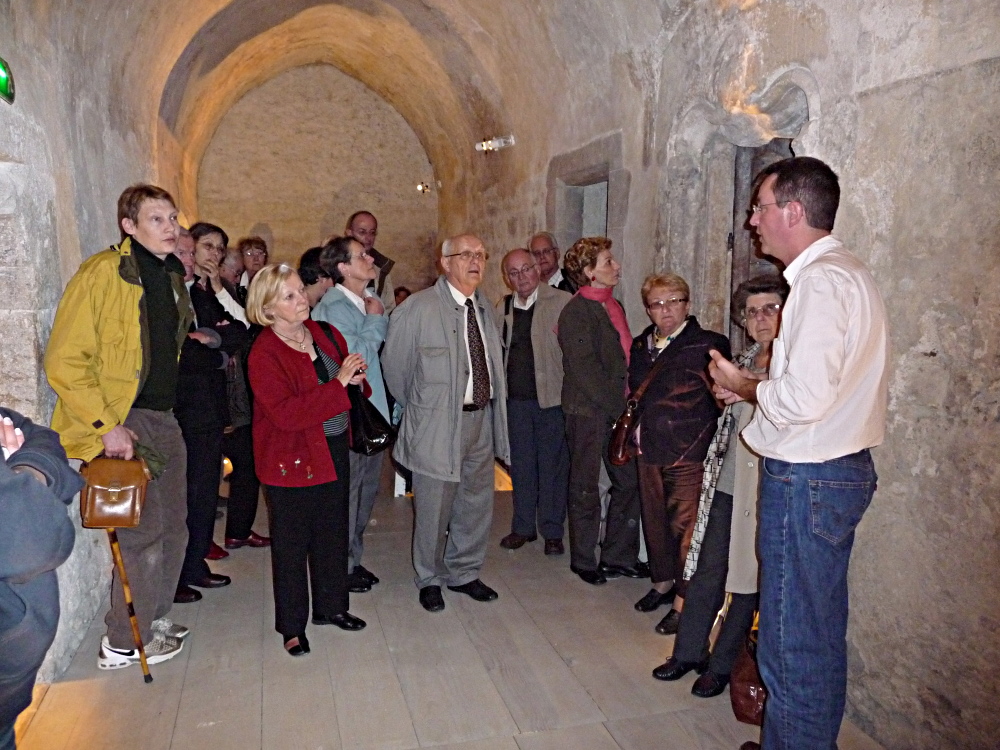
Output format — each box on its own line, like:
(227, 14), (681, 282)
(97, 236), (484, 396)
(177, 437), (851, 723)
(673, 490), (757, 675)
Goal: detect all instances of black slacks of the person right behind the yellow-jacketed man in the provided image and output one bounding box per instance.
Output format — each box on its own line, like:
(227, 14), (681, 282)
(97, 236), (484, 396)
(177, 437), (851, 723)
(180, 425), (222, 586)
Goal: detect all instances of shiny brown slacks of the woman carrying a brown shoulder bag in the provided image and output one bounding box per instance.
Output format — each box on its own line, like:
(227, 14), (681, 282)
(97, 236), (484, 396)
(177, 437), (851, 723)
(639, 459), (704, 596)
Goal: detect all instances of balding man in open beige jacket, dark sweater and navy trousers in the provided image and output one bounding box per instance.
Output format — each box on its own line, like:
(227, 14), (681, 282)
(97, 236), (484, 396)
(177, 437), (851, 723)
(496, 248), (572, 555)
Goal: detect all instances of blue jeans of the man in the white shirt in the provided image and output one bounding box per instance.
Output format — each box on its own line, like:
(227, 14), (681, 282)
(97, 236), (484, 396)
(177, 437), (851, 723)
(757, 450), (877, 750)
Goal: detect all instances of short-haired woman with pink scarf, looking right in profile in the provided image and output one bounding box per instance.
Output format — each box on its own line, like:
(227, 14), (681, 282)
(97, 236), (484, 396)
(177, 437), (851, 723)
(558, 237), (642, 586)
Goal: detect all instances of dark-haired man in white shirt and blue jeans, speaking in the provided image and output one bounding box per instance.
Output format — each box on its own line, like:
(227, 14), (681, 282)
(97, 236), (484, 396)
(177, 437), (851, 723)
(710, 157), (889, 750)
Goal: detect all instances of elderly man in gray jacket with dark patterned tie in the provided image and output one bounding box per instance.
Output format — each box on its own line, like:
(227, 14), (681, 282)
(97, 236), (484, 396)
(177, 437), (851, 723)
(382, 235), (510, 612)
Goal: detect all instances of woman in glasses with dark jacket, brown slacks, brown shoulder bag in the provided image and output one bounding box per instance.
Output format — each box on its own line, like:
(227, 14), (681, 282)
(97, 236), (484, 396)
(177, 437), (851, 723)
(628, 273), (730, 635)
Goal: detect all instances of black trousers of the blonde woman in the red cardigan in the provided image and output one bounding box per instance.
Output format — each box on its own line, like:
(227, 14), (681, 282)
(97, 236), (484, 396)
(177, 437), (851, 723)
(266, 433), (351, 640)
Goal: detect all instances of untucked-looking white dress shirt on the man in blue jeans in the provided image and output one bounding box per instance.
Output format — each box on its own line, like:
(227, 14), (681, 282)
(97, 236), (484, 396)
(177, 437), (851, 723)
(743, 236), (889, 463)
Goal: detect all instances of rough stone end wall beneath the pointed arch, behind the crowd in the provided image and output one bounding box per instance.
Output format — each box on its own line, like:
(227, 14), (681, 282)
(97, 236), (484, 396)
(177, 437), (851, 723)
(198, 65), (438, 290)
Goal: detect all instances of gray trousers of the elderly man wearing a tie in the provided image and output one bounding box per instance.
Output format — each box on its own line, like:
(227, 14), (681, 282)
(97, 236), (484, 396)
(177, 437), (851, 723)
(413, 407), (494, 588)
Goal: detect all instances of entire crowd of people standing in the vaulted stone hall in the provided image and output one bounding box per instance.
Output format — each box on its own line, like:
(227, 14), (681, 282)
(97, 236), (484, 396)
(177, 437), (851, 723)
(0, 157), (887, 748)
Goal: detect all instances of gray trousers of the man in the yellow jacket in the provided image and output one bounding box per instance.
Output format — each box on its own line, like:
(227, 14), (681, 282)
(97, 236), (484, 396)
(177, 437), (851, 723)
(104, 409), (188, 649)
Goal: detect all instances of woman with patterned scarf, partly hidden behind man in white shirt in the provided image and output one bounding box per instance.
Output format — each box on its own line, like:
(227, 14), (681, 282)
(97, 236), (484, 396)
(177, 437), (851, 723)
(653, 275), (789, 698)
